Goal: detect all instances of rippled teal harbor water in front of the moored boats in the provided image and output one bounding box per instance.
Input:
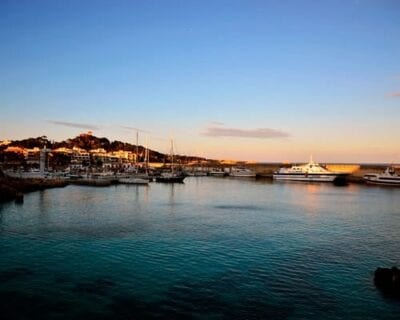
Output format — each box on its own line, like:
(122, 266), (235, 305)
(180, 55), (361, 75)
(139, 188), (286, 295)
(0, 177), (400, 319)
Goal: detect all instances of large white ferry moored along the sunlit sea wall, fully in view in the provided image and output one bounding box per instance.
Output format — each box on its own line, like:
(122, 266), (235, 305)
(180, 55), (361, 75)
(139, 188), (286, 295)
(272, 157), (348, 184)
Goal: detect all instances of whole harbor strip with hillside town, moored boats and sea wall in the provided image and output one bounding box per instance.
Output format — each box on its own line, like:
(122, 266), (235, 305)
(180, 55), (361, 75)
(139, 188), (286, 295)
(0, 131), (400, 201)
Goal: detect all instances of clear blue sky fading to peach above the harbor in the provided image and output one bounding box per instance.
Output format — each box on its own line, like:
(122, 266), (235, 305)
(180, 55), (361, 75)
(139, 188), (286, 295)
(0, 0), (400, 163)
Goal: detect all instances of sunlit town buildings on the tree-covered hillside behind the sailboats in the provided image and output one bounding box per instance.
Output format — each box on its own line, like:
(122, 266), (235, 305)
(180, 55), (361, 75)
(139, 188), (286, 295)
(0, 131), (205, 172)
